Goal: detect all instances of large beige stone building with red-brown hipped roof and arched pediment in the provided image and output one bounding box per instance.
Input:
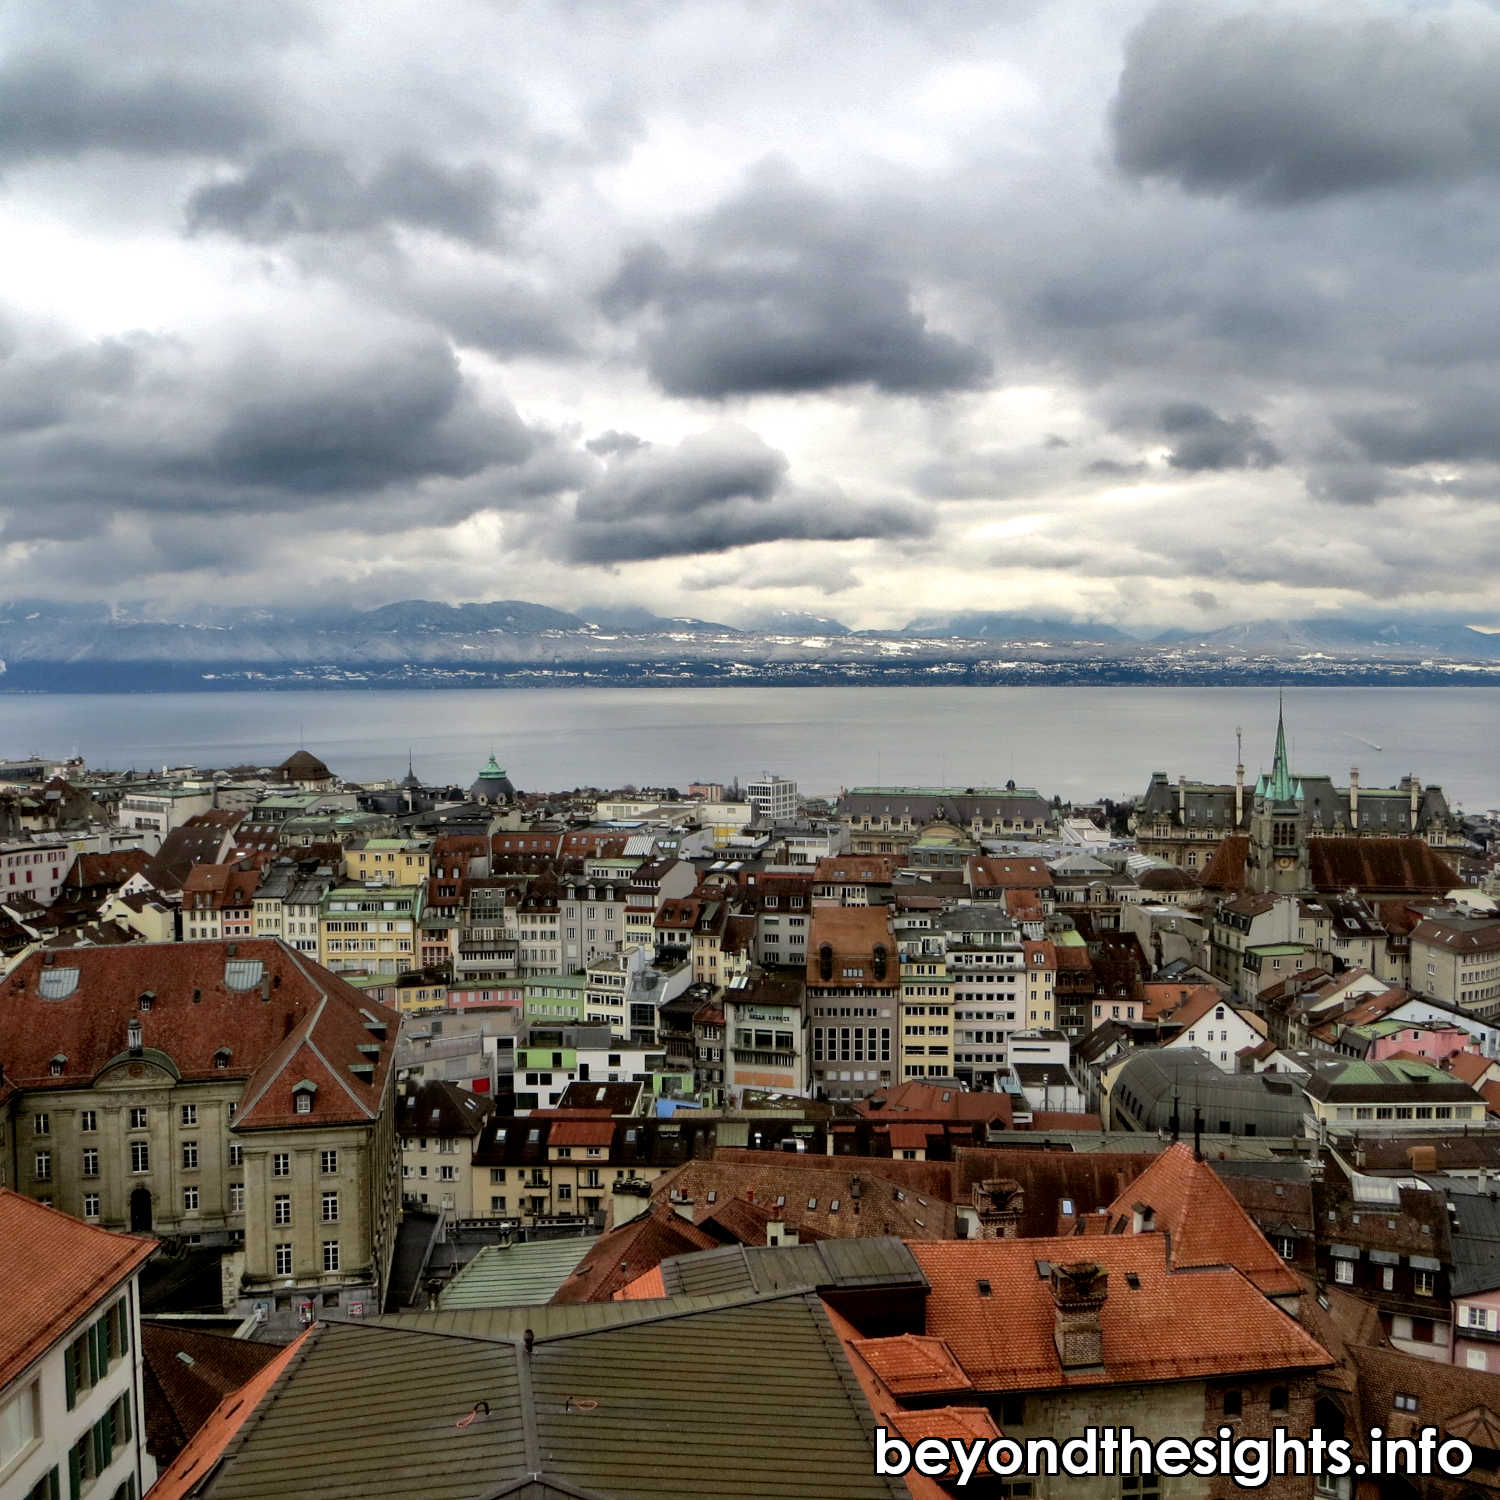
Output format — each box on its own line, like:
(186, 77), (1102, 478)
(0, 939), (399, 1320)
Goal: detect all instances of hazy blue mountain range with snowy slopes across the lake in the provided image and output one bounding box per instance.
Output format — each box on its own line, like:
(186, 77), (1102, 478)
(0, 599), (1500, 692)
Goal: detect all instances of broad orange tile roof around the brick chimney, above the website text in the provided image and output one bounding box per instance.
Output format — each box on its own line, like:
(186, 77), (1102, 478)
(908, 1235), (1331, 1391)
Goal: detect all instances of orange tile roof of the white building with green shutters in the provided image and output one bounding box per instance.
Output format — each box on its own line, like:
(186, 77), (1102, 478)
(0, 1188), (156, 1391)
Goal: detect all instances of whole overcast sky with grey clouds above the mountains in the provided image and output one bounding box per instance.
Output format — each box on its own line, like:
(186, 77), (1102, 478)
(0, 0), (1500, 627)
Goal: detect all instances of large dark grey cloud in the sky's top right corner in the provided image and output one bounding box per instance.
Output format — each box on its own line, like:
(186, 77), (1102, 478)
(1110, 5), (1500, 204)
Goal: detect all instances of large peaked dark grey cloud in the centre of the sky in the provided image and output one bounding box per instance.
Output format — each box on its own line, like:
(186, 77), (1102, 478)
(600, 167), (990, 399)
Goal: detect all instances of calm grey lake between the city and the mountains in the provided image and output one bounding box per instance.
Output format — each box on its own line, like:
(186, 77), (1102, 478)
(0, 687), (1500, 812)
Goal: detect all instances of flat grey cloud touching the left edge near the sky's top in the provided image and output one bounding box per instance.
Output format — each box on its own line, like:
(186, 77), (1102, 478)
(0, 57), (266, 165)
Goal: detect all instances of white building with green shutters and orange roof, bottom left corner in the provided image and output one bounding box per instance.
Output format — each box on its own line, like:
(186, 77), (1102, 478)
(0, 1190), (156, 1500)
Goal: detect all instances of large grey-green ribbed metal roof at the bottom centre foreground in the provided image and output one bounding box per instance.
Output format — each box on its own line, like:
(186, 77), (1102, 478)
(200, 1293), (906, 1500)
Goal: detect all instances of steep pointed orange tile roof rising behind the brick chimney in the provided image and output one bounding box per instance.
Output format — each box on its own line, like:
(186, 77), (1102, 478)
(1110, 1142), (1299, 1296)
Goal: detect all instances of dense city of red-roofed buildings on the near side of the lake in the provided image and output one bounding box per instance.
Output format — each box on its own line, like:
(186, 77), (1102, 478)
(0, 710), (1500, 1496)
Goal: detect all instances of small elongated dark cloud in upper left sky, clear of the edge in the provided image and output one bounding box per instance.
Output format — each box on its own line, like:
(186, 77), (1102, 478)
(188, 146), (519, 245)
